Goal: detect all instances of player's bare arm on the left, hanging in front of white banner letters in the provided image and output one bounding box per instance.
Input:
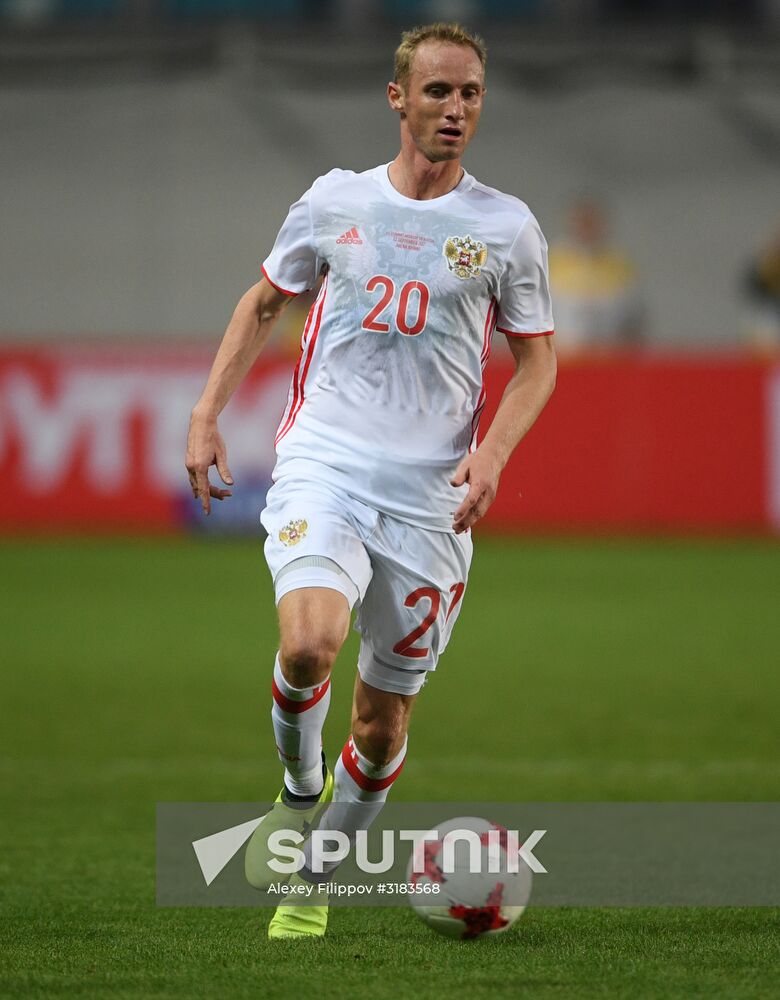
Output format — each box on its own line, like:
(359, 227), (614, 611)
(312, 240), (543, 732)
(186, 278), (292, 514)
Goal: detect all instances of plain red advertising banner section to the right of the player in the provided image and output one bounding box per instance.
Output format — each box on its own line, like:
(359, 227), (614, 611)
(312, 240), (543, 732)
(490, 356), (780, 532)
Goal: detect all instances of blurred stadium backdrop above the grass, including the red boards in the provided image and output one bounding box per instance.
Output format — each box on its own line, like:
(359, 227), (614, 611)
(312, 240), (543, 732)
(0, 0), (780, 533)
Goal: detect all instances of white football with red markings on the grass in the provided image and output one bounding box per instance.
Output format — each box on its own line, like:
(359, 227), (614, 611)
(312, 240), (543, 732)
(407, 816), (532, 940)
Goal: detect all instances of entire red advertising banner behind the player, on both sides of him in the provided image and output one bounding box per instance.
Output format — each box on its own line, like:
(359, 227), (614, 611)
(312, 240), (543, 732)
(0, 345), (780, 534)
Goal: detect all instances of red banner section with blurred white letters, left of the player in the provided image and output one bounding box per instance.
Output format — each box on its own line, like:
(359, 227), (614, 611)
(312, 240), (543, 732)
(0, 346), (292, 533)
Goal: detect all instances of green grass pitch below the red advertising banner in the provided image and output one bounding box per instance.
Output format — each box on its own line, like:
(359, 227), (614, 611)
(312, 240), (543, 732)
(0, 538), (780, 1000)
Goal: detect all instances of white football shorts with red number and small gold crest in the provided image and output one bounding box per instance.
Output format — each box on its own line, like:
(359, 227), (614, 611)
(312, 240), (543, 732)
(261, 477), (472, 694)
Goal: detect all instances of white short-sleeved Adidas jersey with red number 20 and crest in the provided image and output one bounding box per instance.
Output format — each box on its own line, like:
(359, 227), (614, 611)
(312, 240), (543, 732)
(263, 164), (553, 531)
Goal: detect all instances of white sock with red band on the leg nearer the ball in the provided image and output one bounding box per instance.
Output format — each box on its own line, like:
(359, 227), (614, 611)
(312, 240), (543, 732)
(303, 736), (408, 874)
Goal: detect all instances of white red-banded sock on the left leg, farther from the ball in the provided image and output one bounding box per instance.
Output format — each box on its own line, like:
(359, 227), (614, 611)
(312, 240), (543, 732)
(271, 653), (330, 795)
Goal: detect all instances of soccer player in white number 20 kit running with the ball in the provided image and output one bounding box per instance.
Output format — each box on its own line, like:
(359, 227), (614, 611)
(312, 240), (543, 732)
(186, 24), (555, 938)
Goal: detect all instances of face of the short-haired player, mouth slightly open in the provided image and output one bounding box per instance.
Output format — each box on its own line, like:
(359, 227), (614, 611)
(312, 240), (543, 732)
(391, 42), (485, 163)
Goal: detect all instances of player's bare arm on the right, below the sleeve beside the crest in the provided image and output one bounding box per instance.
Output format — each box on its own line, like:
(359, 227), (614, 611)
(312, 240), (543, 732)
(452, 337), (557, 534)
